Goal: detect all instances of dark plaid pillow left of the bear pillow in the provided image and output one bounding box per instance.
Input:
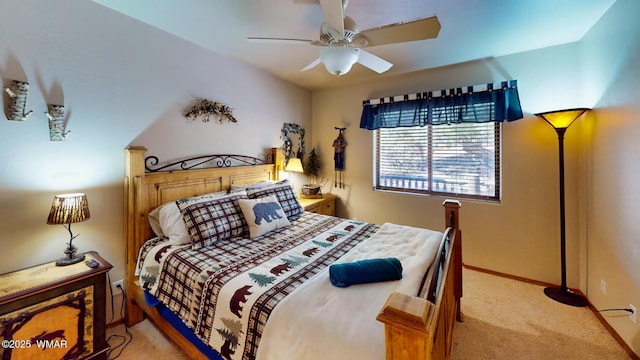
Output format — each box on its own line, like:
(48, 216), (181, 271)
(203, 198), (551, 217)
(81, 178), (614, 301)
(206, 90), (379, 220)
(176, 192), (249, 250)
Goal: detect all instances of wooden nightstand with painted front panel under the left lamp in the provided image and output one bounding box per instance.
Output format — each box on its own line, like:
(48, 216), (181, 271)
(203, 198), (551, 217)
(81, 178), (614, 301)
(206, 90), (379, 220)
(0, 252), (112, 359)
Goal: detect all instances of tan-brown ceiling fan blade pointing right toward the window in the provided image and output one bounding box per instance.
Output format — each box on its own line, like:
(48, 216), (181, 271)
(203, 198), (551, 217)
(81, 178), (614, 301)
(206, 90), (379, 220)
(360, 16), (440, 46)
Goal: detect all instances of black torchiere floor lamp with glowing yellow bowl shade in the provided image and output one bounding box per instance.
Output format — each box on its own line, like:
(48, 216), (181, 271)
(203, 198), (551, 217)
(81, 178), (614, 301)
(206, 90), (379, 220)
(536, 108), (590, 306)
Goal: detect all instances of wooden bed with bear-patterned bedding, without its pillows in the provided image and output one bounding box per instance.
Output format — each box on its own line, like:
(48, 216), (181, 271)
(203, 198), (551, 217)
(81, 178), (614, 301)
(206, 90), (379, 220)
(124, 147), (462, 359)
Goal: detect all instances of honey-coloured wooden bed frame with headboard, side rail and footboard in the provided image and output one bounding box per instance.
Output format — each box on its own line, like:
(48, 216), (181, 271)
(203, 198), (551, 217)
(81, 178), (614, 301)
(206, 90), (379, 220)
(124, 147), (462, 360)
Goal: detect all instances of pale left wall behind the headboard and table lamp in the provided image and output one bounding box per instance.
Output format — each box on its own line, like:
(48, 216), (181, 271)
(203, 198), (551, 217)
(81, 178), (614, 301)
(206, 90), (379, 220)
(0, 0), (311, 320)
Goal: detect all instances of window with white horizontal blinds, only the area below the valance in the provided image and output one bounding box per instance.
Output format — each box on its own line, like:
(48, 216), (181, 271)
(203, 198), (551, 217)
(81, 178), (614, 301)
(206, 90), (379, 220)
(374, 122), (502, 200)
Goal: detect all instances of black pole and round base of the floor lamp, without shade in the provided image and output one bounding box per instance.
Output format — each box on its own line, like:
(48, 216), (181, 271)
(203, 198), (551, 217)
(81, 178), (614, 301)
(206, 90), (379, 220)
(544, 128), (587, 306)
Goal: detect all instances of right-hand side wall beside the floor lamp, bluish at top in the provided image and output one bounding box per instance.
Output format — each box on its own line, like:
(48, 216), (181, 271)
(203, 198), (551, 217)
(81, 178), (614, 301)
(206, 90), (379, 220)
(583, 0), (640, 354)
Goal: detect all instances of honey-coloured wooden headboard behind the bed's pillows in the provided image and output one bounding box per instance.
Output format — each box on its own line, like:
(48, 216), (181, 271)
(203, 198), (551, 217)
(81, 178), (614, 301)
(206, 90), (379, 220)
(124, 146), (280, 324)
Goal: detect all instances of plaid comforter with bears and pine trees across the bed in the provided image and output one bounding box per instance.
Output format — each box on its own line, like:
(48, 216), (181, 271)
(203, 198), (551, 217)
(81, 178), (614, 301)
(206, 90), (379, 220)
(138, 213), (379, 359)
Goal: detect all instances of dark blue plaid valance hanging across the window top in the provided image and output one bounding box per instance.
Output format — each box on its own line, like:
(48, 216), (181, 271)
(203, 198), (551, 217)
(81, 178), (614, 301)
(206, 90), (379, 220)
(360, 80), (523, 130)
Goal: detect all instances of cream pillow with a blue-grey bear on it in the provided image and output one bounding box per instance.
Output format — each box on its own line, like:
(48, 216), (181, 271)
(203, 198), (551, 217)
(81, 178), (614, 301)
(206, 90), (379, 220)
(238, 195), (291, 239)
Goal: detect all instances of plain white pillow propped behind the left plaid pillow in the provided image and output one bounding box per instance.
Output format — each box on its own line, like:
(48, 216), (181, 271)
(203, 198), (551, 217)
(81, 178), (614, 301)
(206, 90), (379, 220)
(148, 191), (238, 245)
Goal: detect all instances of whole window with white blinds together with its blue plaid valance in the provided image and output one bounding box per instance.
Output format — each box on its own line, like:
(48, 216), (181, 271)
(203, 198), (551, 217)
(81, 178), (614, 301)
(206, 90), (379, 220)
(360, 80), (523, 201)
